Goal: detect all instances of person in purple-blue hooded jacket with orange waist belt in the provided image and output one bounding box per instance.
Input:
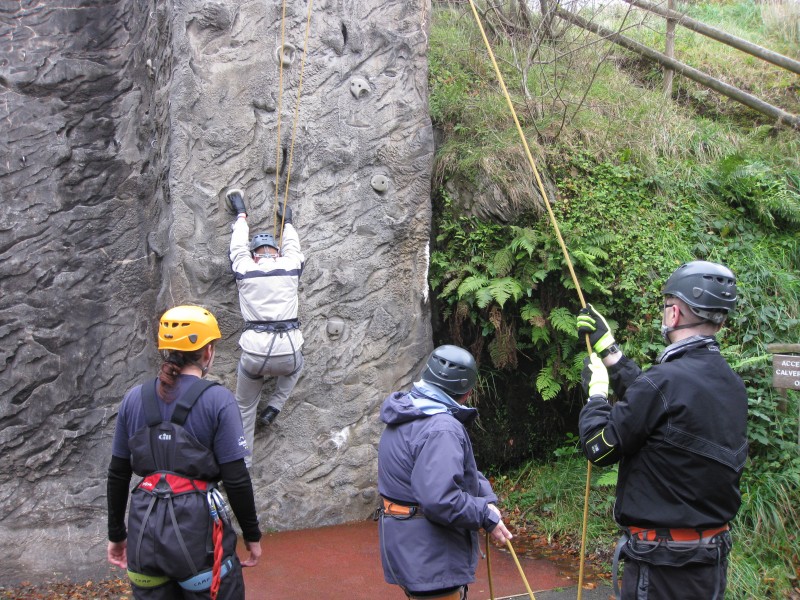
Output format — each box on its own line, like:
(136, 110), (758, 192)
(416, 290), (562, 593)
(378, 346), (512, 600)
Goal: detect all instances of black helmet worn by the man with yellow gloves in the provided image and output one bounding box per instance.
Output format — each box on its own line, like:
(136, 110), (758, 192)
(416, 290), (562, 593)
(662, 260), (736, 325)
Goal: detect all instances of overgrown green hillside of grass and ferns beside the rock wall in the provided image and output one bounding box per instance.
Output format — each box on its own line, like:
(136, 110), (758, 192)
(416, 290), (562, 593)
(429, 0), (800, 598)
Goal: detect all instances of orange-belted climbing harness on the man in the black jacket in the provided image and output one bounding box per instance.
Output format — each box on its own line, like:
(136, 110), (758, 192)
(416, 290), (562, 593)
(611, 525), (731, 600)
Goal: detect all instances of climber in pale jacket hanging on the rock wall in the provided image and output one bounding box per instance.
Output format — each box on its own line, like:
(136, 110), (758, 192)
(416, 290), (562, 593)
(227, 189), (305, 466)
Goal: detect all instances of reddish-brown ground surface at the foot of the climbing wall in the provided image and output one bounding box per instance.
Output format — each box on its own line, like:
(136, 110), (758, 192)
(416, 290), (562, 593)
(239, 520), (613, 600)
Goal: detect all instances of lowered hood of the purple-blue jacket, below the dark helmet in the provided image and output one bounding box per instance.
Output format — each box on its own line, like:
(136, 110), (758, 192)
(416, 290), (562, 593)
(381, 380), (478, 425)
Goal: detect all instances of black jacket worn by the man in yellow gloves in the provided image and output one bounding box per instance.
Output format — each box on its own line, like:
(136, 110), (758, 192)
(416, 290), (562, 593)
(580, 337), (747, 528)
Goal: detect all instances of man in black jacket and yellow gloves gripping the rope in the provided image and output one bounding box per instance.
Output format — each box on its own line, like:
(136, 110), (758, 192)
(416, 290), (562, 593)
(578, 261), (747, 600)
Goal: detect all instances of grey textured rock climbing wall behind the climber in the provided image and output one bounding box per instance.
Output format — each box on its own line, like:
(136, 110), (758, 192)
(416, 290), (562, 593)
(0, 0), (433, 582)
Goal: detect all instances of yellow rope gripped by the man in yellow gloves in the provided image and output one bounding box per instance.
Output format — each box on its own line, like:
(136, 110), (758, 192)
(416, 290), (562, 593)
(469, 0), (592, 600)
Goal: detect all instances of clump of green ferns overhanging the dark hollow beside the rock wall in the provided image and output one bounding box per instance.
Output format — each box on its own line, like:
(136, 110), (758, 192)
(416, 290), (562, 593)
(429, 191), (607, 400)
